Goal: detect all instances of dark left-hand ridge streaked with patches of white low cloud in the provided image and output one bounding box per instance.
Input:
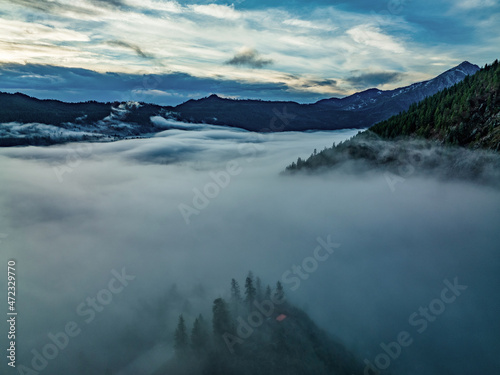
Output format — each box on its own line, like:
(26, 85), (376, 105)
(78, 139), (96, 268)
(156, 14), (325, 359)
(0, 93), (165, 146)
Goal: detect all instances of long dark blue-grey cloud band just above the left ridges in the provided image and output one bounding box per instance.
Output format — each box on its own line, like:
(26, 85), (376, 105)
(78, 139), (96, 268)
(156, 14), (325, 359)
(0, 64), (316, 105)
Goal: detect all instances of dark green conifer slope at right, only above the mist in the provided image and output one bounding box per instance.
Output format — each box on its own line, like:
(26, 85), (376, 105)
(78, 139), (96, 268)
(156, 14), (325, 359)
(370, 60), (500, 151)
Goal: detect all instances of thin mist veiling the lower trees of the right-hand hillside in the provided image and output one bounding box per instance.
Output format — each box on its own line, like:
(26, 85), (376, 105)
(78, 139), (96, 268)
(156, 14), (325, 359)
(287, 133), (500, 188)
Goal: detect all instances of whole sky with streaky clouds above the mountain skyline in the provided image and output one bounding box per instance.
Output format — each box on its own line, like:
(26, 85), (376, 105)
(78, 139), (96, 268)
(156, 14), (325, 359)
(0, 0), (500, 104)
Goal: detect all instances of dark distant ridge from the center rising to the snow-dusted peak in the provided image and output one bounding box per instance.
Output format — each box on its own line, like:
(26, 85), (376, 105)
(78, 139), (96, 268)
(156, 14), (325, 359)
(174, 61), (479, 131)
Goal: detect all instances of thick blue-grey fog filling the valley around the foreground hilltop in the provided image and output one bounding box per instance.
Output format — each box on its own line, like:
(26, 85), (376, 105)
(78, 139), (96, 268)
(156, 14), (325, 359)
(0, 125), (500, 375)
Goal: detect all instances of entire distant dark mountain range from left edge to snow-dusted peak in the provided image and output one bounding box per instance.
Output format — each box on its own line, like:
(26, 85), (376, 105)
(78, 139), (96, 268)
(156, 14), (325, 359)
(0, 62), (479, 146)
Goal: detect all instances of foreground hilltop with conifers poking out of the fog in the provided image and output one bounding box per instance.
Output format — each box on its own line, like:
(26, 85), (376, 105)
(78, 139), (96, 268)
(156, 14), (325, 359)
(156, 273), (363, 375)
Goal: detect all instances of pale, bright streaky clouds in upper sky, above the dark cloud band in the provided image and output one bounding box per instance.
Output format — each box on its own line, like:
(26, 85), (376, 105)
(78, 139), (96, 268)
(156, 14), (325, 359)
(0, 0), (498, 100)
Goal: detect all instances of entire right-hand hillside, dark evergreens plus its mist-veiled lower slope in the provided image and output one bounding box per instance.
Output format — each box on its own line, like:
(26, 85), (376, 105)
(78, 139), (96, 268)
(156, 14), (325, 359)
(286, 60), (500, 185)
